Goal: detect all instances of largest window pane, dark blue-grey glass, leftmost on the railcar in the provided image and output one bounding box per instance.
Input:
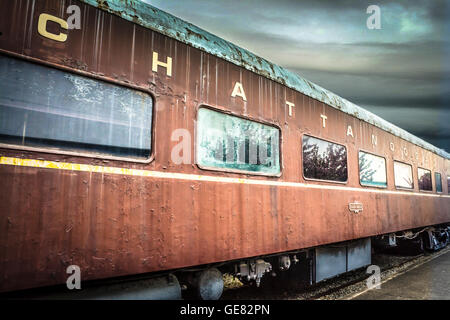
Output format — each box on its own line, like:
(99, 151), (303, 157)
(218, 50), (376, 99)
(0, 56), (153, 158)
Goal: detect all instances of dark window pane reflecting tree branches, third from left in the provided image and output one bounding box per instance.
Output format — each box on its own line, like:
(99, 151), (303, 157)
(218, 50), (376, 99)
(303, 135), (348, 182)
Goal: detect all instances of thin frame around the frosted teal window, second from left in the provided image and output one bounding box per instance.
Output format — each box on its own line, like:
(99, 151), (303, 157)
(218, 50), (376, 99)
(194, 103), (283, 178)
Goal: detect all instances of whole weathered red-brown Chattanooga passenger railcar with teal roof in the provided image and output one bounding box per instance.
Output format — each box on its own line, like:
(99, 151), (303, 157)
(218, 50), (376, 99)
(0, 0), (450, 298)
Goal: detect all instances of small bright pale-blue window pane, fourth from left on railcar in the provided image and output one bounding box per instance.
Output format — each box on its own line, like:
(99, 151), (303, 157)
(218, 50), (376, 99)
(359, 151), (387, 188)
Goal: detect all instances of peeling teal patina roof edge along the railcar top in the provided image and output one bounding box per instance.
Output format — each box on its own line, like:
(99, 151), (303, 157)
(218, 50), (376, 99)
(81, 0), (450, 159)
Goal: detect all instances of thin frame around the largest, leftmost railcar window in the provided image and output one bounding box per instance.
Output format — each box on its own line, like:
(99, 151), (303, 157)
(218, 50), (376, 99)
(0, 49), (157, 164)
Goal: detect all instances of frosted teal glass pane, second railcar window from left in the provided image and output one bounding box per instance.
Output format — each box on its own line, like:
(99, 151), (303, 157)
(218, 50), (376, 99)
(196, 108), (280, 175)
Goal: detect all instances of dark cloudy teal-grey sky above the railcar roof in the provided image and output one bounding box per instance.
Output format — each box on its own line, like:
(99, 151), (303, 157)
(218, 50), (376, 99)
(143, 0), (450, 152)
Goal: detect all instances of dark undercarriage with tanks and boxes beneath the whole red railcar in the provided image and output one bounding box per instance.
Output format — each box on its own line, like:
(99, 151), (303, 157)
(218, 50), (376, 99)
(2, 224), (450, 300)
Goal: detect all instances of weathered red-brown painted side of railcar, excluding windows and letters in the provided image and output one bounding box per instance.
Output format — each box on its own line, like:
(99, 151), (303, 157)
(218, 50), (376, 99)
(0, 0), (450, 291)
